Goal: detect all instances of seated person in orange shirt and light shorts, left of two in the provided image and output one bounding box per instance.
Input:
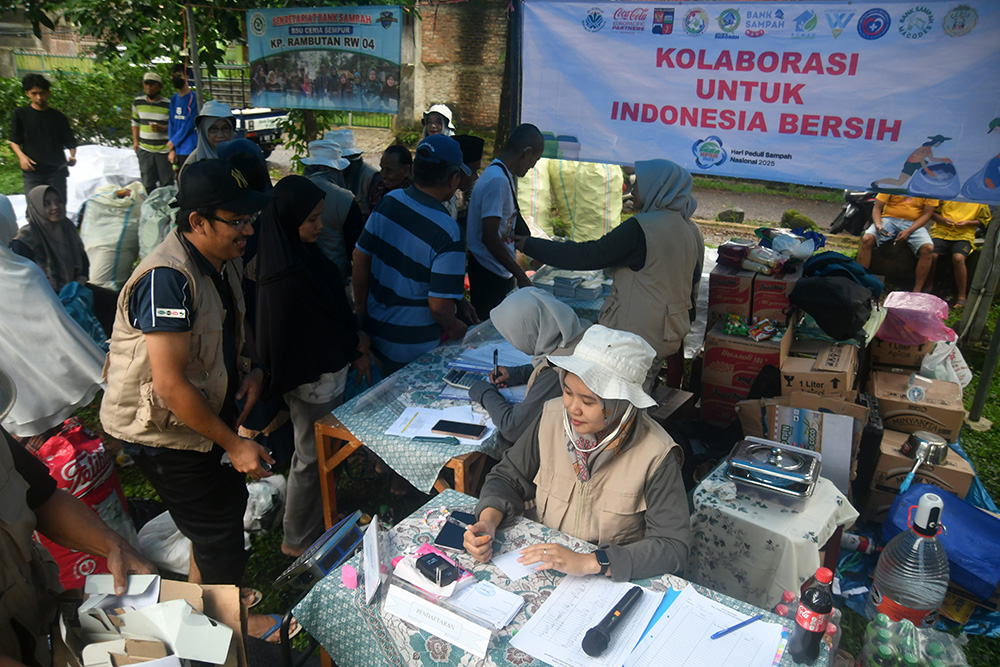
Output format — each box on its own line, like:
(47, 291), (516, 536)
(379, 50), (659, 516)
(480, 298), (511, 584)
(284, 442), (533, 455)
(857, 192), (938, 292)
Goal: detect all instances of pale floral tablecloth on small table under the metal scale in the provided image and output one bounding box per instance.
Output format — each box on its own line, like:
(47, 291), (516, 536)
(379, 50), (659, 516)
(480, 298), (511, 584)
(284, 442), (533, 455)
(684, 464), (858, 609)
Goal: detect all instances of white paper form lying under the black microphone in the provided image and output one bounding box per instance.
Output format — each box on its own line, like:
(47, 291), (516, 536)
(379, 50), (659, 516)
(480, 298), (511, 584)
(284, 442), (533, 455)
(510, 576), (664, 667)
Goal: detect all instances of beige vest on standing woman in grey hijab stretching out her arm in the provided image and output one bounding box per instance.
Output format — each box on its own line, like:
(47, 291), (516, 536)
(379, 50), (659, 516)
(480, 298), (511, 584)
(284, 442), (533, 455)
(597, 211), (705, 358)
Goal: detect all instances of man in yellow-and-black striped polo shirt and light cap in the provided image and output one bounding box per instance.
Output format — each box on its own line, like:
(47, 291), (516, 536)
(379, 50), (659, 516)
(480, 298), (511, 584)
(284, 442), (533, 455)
(132, 72), (174, 194)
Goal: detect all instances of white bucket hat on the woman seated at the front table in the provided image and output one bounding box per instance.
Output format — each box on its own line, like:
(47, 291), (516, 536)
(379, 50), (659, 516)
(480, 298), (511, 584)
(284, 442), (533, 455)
(548, 324), (656, 408)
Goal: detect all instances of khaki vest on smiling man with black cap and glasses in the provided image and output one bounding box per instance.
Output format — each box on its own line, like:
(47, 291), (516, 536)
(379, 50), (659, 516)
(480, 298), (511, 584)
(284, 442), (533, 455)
(101, 231), (244, 452)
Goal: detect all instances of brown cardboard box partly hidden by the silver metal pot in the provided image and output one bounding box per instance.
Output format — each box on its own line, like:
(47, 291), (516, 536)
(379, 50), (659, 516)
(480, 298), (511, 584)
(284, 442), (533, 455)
(872, 430), (976, 499)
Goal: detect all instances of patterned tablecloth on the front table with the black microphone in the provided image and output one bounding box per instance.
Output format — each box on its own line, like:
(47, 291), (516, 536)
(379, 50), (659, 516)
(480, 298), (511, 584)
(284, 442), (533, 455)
(293, 490), (829, 667)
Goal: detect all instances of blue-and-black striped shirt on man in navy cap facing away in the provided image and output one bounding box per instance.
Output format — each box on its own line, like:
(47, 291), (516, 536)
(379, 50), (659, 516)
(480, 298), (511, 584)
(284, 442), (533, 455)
(357, 186), (465, 365)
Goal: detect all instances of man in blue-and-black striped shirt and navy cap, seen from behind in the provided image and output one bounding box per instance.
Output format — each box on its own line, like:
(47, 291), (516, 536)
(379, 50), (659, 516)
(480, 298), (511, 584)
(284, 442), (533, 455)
(352, 135), (475, 374)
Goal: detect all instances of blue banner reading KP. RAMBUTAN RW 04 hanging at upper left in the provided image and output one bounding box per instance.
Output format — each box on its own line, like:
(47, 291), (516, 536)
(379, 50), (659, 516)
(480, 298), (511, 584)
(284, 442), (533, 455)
(247, 5), (402, 113)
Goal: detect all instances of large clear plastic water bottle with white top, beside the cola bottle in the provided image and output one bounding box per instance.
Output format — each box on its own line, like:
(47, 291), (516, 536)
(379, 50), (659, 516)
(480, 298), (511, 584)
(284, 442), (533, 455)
(865, 493), (948, 628)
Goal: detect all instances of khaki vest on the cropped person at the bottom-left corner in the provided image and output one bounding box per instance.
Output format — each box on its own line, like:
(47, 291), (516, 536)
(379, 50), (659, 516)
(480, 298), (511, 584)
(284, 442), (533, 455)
(0, 434), (62, 665)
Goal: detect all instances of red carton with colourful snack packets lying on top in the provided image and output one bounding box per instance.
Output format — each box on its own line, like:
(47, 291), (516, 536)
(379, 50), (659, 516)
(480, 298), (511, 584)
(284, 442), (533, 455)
(701, 322), (794, 398)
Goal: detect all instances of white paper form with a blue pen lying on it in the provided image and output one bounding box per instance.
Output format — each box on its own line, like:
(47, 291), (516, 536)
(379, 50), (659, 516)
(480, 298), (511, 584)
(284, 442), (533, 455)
(625, 586), (781, 667)
